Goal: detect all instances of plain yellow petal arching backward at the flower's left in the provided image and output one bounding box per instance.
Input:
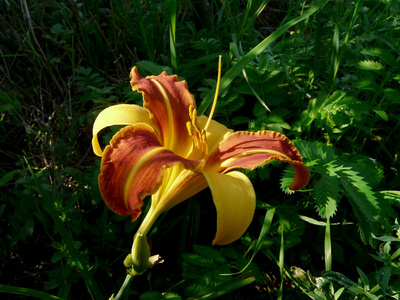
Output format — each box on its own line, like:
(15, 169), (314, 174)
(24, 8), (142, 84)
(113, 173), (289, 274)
(92, 104), (151, 156)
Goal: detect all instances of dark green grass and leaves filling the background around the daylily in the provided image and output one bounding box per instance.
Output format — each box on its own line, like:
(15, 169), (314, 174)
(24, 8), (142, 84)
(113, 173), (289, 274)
(0, 0), (400, 299)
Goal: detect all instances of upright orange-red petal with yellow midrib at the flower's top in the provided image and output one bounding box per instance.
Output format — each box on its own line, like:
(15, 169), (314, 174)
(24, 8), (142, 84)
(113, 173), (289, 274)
(130, 67), (196, 157)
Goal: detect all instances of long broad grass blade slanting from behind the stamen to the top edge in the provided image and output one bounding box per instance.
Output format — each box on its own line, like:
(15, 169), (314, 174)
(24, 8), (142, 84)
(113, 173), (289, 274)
(198, 0), (329, 115)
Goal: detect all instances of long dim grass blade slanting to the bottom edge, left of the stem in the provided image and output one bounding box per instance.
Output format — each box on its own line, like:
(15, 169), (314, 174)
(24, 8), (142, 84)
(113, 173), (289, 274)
(24, 157), (104, 299)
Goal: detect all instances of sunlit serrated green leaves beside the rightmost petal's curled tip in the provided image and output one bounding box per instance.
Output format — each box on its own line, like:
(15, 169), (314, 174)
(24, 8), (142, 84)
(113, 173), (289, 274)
(281, 141), (393, 243)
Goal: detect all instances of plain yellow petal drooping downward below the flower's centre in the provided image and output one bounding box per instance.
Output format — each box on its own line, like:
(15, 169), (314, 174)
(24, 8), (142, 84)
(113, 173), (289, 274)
(204, 171), (256, 245)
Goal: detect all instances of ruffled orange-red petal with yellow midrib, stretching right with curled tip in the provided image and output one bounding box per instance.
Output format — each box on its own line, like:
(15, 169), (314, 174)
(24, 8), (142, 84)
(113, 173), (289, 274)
(204, 131), (310, 190)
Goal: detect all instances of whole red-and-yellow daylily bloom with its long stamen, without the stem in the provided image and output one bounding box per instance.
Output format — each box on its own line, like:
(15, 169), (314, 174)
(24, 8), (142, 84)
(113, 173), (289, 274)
(92, 58), (310, 255)
